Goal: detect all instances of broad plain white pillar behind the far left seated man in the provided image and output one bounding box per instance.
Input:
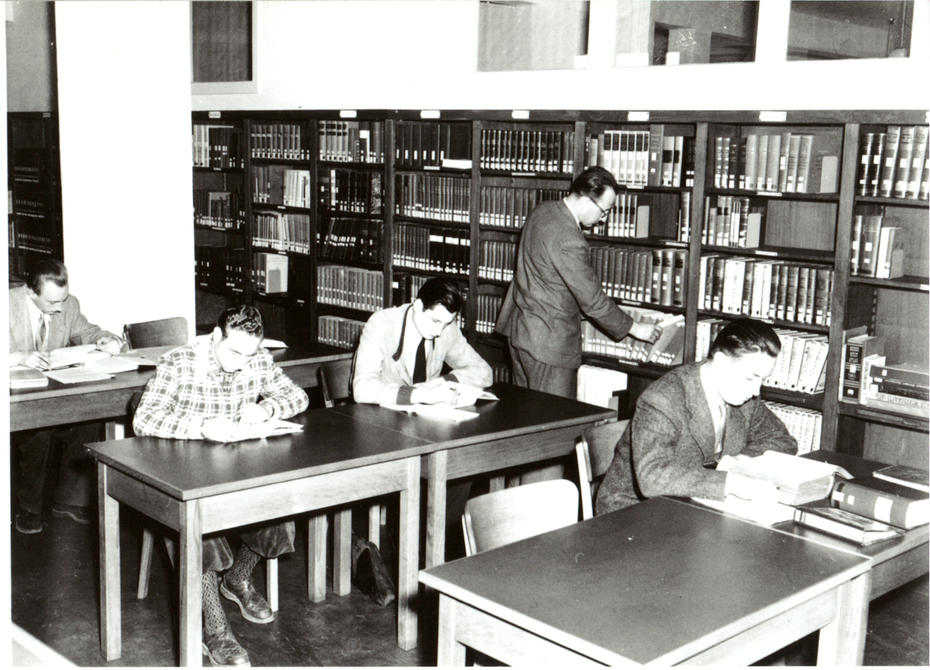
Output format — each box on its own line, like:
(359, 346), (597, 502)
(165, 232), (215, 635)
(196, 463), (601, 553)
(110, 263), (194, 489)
(56, 1), (194, 332)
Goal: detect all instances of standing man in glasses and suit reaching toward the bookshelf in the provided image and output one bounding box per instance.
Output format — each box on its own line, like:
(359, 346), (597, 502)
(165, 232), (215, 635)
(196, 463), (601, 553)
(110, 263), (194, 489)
(496, 167), (659, 398)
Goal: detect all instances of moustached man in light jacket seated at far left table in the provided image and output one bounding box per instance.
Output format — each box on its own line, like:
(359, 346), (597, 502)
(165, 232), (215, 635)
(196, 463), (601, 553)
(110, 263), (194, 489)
(9, 259), (122, 534)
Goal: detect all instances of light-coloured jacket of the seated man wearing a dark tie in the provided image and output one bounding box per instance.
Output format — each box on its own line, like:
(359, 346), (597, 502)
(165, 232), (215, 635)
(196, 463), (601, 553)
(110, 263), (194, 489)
(352, 303), (493, 405)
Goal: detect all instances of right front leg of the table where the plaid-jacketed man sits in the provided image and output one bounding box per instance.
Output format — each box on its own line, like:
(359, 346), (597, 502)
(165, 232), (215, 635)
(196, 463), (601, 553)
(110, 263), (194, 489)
(397, 458), (420, 651)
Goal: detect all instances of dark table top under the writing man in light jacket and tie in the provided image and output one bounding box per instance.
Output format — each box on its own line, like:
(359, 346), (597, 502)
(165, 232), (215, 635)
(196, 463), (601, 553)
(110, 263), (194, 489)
(336, 384), (616, 448)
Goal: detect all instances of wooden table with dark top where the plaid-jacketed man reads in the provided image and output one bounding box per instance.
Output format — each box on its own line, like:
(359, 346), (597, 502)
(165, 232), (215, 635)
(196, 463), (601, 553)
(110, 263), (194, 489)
(88, 409), (429, 666)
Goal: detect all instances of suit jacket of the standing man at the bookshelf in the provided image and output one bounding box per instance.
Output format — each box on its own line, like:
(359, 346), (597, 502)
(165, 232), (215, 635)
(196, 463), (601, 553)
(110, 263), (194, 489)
(496, 200), (633, 368)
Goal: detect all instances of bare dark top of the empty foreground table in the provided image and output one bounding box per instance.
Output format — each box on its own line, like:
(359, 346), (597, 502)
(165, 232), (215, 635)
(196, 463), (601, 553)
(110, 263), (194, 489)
(420, 498), (868, 664)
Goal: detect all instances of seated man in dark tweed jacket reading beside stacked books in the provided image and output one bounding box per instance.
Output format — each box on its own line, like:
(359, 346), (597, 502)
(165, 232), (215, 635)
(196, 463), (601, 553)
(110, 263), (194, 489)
(595, 319), (797, 514)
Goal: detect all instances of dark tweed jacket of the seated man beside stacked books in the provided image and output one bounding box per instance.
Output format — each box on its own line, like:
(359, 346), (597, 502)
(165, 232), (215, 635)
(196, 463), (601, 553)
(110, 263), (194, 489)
(596, 363), (797, 514)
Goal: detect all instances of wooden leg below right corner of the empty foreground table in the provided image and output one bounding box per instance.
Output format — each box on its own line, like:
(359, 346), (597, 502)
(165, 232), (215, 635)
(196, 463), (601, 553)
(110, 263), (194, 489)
(817, 572), (872, 667)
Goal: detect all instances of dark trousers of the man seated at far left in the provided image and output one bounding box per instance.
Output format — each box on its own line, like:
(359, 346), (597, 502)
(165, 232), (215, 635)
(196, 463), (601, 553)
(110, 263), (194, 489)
(10, 423), (102, 514)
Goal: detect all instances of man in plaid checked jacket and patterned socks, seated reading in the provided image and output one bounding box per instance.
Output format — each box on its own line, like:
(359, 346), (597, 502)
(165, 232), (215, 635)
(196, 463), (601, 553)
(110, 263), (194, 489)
(133, 305), (308, 666)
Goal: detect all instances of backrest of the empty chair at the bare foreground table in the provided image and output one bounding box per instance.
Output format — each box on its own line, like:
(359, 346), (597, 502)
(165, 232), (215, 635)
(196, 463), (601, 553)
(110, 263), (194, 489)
(462, 479), (578, 556)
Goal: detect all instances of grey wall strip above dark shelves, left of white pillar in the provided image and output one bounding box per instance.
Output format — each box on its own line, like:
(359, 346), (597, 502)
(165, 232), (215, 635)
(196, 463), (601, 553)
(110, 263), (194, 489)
(4, 0), (54, 112)
